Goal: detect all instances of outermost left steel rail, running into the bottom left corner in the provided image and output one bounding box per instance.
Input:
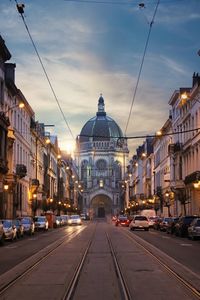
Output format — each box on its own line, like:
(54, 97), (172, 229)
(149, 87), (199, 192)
(0, 228), (85, 298)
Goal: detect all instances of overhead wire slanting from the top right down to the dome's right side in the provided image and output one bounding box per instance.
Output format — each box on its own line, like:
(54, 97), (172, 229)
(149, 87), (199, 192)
(124, 0), (160, 136)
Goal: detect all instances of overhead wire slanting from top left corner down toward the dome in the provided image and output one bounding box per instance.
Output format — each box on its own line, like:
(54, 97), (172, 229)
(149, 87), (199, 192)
(15, 0), (75, 140)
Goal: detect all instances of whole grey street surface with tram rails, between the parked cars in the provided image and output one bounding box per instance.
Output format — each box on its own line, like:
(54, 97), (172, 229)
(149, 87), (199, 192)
(0, 220), (200, 300)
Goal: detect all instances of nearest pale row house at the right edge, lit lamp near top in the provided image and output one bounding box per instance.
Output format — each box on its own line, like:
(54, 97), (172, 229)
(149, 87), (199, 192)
(169, 73), (200, 214)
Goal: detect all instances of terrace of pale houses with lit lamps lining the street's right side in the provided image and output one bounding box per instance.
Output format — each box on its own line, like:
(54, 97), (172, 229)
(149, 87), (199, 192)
(125, 73), (200, 216)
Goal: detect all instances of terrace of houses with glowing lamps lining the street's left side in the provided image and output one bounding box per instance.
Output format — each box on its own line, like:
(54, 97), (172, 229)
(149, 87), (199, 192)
(0, 36), (81, 218)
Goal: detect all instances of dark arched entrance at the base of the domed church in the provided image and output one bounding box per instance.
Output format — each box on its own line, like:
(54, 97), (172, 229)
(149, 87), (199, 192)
(91, 195), (112, 218)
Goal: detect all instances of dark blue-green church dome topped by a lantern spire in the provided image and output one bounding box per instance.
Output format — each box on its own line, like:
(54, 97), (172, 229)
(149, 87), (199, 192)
(79, 95), (123, 143)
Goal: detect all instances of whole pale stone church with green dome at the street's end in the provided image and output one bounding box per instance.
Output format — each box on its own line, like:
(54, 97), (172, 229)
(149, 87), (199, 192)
(75, 95), (129, 217)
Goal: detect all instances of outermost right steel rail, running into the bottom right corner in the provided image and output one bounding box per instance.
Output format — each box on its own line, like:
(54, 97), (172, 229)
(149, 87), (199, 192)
(123, 232), (200, 299)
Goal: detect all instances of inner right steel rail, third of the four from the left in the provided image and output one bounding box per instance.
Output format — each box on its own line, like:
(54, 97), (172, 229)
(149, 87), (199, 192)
(106, 232), (132, 300)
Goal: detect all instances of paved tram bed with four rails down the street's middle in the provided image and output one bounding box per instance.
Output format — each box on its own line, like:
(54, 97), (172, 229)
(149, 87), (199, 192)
(0, 222), (200, 300)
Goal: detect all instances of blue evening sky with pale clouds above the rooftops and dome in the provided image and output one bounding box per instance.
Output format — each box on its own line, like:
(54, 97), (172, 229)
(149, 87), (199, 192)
(0, 0), (200, 156)
